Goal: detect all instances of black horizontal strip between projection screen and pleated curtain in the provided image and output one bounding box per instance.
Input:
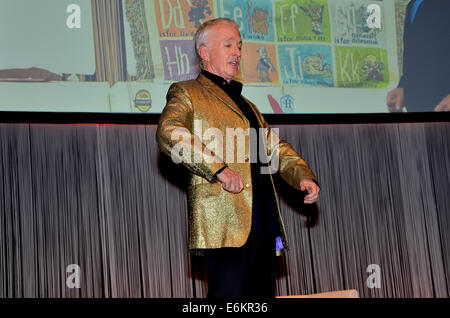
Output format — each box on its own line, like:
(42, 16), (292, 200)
(0, 111), (450, 125)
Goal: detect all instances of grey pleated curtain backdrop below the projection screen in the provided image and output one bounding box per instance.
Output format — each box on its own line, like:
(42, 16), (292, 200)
(0, 123), (450, 298)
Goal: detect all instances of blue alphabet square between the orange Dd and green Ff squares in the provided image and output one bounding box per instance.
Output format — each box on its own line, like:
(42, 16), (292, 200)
(217, 0), (275, 41)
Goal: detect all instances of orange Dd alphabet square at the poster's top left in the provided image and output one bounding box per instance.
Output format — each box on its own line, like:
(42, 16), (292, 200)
(154, 0), (214, 38)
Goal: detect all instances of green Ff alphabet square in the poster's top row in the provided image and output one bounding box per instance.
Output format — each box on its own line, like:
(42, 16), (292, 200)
(275, 0), (330, 43)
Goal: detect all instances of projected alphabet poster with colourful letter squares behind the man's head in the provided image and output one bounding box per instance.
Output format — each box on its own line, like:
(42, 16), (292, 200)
(147, 0), (398, 102)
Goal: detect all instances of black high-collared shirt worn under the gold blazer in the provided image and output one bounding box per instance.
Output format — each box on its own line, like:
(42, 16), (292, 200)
(202, 70), (279, 236)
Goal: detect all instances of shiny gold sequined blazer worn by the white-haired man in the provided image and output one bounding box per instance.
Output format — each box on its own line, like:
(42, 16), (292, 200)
(156, 74), (316, 254)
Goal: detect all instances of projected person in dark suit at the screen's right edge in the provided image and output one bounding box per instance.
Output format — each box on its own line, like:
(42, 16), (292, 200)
(386, 0), (450, 112)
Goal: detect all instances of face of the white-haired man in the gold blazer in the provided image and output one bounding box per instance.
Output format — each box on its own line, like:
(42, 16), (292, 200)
(199, 23), (242, 82)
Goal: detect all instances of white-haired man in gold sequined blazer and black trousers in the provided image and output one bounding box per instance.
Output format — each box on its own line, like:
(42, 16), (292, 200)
(157, 18), (320, 297)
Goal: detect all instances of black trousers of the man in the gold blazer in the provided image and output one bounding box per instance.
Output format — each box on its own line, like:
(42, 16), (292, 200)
(205, 232), (276, 298)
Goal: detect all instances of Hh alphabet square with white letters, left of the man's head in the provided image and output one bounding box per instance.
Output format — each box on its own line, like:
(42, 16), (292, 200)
(160, 40), (200, 81)
